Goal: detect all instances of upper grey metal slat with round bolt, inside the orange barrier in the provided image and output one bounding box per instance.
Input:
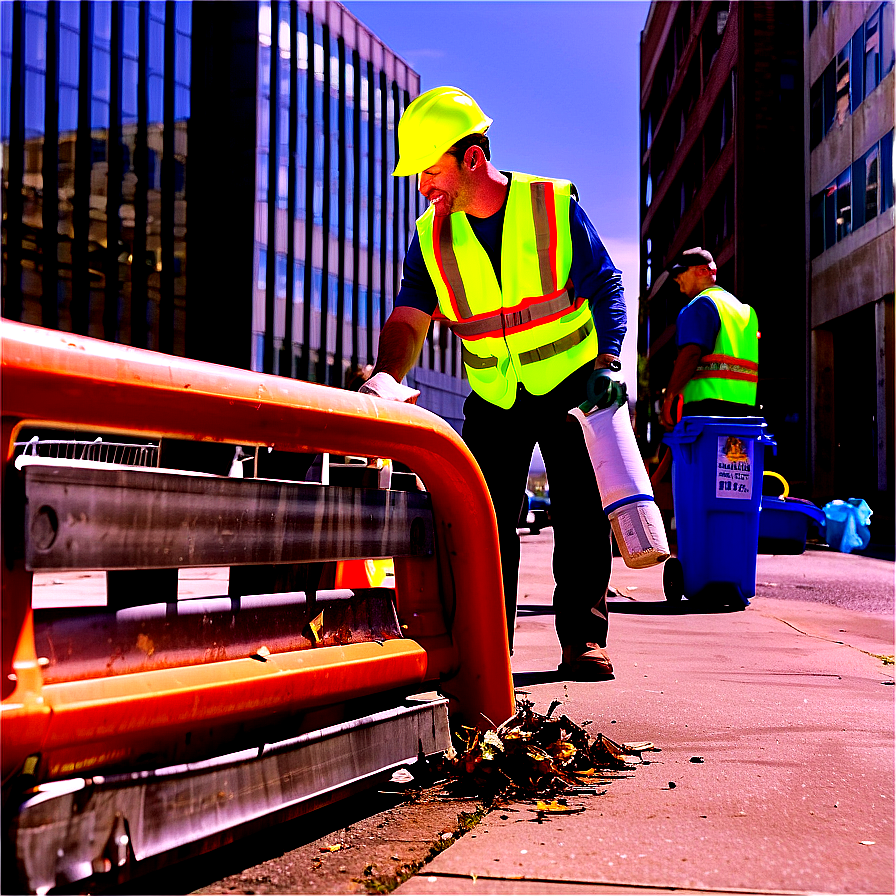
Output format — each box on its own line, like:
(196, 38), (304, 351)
(22, 462), (433, 571)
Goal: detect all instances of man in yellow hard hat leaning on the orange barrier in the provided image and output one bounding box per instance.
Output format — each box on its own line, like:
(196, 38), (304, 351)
(362, 87), (626, 679)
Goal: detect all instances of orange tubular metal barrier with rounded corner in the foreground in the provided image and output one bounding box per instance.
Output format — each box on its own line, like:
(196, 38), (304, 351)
(0, 321), (514, 779)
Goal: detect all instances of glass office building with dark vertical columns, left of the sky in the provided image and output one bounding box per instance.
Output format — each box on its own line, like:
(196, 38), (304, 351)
(0, 0), (468, 422)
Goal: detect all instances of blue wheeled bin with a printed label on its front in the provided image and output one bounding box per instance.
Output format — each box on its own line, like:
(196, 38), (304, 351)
(663, 417), (777, 609)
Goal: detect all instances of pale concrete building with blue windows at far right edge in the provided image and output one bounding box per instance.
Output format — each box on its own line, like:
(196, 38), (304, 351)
(803, 0), (896, 520)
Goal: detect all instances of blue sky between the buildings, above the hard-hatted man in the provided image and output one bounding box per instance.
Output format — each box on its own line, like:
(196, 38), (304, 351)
(343, 0), (650, 378)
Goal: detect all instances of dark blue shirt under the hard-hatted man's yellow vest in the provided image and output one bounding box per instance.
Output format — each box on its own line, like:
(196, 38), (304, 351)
(395, 172), (627, 355)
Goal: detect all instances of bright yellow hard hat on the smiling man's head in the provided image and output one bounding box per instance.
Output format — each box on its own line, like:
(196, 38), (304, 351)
(392, 87), (492, 177)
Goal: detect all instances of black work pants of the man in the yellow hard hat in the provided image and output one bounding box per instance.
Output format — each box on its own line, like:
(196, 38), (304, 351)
(463, 363), (613, 648)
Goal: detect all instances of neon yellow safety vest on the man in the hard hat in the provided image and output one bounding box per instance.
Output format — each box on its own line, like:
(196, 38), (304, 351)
(417, 173), (597, 408)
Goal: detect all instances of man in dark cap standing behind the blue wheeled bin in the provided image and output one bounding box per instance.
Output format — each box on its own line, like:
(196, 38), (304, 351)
(660, 246), (759, 429)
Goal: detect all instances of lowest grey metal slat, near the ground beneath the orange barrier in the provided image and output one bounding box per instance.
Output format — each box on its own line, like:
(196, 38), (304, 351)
(13, 699), (451, 893)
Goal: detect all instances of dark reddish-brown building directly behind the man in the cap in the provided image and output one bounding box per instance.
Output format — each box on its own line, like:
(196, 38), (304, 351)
(636, 0), (808, 488)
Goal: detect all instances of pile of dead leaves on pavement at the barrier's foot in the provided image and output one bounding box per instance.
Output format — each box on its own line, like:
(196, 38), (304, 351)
(443, 699), (657, 797)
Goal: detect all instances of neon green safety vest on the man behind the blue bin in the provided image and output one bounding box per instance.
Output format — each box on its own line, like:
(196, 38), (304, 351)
(682, 286), (759, 404)
